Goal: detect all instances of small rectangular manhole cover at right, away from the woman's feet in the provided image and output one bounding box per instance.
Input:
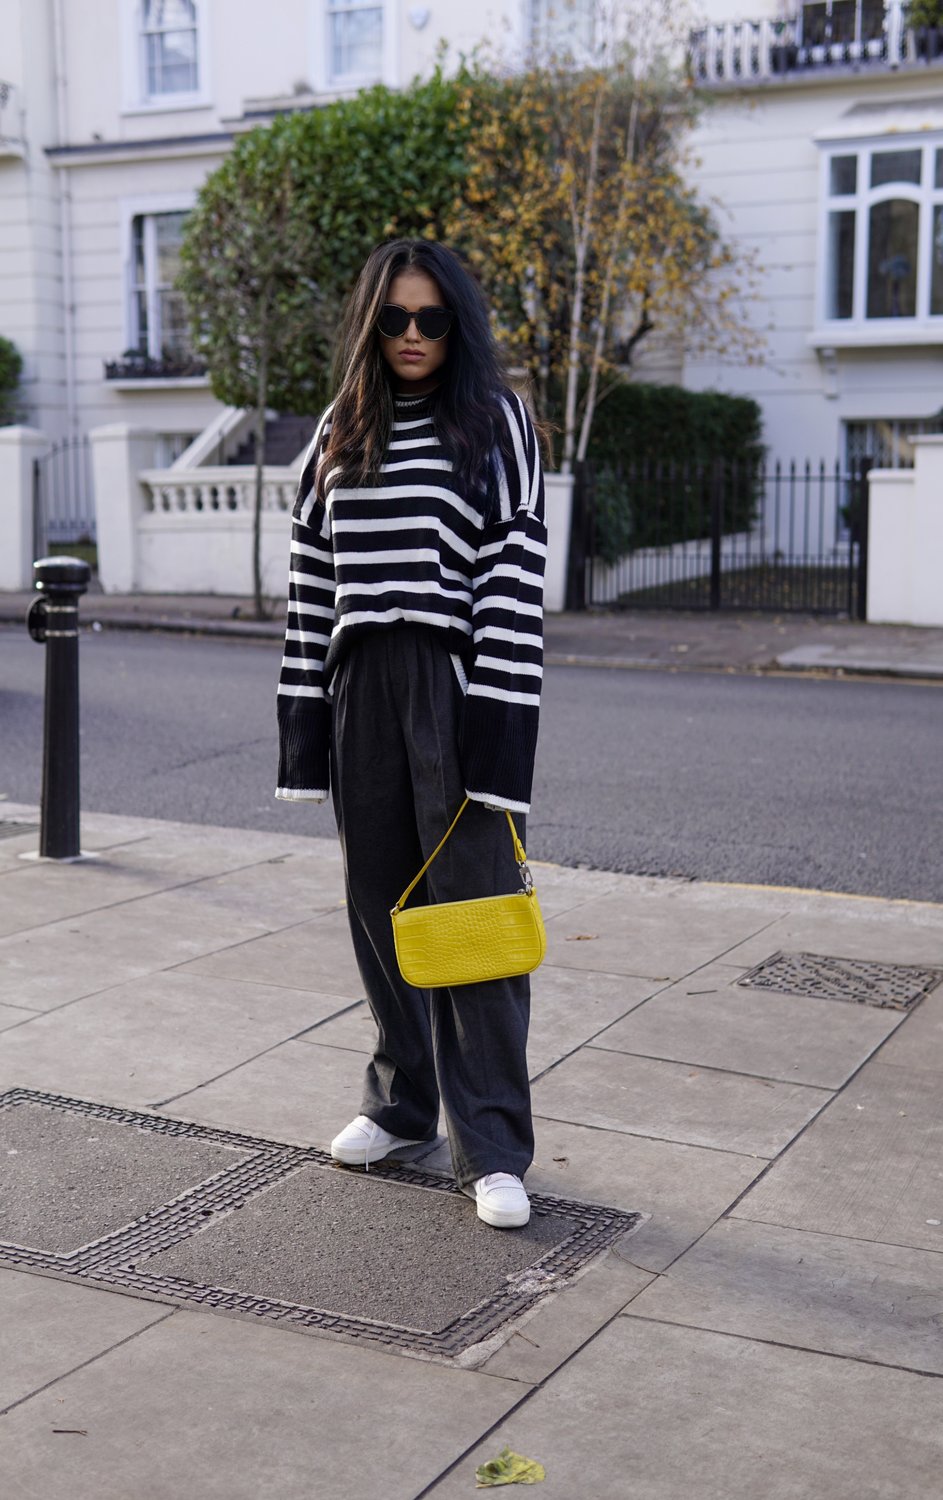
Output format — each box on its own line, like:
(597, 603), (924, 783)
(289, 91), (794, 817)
(736, 953), (943, 1011)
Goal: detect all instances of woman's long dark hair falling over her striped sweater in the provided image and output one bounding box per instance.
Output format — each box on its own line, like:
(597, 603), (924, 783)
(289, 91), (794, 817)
(318, 240), (510, 500)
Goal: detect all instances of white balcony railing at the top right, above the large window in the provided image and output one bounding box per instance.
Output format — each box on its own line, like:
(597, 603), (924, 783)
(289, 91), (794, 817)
(690, 0), (943, 84)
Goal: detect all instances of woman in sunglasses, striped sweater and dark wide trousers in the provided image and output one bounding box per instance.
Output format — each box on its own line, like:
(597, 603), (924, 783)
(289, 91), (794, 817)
(276, 240), (546, 1227)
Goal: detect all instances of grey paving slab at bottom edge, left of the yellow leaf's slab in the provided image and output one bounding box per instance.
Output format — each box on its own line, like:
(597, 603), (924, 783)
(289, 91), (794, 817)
(3, 1311), (522, 1500)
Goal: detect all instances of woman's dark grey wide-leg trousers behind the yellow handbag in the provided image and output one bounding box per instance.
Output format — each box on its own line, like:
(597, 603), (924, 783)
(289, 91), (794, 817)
(331, 626), (534, 1185)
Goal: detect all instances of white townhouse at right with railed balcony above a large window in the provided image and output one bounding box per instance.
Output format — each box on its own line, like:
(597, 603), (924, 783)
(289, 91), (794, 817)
(682, 0), (943, 468)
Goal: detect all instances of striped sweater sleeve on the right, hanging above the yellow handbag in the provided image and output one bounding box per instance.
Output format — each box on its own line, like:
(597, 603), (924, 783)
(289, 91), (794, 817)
(462, 395), (547, 813)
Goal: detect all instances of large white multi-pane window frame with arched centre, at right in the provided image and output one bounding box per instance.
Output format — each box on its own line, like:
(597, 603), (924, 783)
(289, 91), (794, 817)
(811, 131), (943, 347)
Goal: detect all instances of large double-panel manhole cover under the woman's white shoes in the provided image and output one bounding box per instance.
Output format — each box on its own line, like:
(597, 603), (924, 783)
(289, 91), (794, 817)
(0, 1089), (645, 1356)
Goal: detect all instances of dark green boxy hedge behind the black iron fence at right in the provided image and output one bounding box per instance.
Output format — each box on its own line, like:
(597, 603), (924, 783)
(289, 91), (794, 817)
(588, 384), (765, 563)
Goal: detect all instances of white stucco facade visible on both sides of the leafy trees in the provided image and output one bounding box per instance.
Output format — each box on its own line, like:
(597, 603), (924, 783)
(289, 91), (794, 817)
(0, 0), (943, 489)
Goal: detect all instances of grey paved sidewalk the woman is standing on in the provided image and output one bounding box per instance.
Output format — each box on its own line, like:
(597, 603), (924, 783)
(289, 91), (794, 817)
(0, 804), (943, 1500)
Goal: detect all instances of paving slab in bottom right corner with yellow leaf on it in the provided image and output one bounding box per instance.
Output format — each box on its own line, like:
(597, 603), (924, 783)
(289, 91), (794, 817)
(430, 1308), (943, 1500)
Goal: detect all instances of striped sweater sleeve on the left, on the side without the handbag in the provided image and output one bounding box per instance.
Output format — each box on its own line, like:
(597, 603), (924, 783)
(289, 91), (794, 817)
(274, 407), (334, 803)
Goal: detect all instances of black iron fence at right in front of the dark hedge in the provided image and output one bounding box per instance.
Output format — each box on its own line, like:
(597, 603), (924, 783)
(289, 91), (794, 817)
(567, 459), (871, 620)
